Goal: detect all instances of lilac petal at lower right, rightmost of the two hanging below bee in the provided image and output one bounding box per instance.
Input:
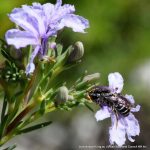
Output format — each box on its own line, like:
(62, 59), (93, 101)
(124, 113), (140, 142)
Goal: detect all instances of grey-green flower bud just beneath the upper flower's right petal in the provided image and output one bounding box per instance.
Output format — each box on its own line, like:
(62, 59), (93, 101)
(68, 41), (84, 62)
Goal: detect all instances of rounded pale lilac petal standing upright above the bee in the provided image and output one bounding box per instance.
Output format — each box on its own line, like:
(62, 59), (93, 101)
(108, 72), (123, 93)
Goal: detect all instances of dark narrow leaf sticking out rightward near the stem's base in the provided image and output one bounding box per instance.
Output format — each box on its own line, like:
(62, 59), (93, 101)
(18, 121), (52, 134)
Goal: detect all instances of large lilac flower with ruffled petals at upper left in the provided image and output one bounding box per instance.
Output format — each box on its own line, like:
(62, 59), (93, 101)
(5, 0), (89, 74)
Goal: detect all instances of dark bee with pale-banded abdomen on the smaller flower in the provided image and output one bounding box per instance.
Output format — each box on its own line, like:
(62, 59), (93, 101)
(88, 86), (132, 117)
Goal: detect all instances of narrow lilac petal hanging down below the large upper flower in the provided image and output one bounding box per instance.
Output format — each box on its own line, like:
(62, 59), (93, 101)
(26, 46), (40, 75)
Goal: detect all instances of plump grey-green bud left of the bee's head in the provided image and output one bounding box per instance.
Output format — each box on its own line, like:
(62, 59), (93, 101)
(56, 86), (69, 105)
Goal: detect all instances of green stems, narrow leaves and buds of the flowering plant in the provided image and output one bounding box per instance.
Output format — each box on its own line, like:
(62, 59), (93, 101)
(0, 37), (100, 146)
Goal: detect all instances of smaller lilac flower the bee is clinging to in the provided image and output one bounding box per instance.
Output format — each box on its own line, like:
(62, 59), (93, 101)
(95, 72), (140, 146)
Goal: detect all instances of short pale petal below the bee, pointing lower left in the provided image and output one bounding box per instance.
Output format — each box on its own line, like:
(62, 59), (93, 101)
(95, 106), (111, 121)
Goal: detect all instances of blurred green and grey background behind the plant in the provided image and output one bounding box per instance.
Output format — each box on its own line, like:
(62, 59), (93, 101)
(0, 0), (150, 150)
